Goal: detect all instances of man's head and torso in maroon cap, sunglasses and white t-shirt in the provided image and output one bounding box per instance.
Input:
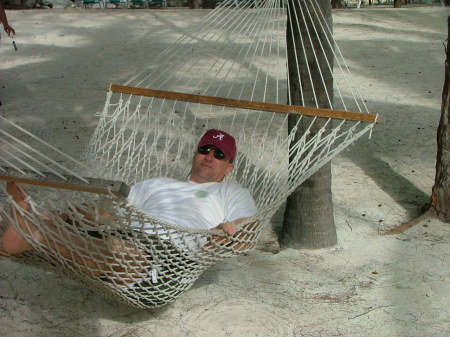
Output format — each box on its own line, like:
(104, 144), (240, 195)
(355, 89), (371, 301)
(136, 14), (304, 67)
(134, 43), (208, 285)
(128, 129), (256, 235)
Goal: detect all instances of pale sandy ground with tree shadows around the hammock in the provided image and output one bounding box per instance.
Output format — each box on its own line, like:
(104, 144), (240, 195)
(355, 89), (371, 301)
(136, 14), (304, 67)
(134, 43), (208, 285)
(0, 8), (450, 337)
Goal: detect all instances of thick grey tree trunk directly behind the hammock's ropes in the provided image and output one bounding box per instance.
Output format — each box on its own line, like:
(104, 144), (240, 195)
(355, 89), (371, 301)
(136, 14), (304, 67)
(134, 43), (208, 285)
(280, 0), (337, 248)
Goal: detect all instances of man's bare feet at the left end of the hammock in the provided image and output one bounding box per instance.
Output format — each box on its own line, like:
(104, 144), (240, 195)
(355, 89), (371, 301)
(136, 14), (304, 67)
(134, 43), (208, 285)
(1, 182), (42, 255)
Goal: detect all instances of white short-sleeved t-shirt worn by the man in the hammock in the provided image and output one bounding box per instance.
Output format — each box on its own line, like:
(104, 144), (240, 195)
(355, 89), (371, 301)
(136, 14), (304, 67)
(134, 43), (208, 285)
(128, 178), (257, 229)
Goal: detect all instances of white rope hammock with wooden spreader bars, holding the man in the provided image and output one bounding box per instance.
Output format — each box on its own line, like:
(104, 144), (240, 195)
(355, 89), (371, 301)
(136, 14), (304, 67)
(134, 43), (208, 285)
(0, 0), (376, 308)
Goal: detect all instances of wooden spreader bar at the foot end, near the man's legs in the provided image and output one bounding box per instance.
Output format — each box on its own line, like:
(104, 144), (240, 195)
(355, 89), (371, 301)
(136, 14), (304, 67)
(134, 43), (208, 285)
(0, 167), (130, 197)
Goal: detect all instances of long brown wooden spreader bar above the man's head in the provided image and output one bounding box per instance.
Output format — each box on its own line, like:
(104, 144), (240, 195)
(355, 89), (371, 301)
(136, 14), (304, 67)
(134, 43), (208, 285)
(109, 84), (377, 123)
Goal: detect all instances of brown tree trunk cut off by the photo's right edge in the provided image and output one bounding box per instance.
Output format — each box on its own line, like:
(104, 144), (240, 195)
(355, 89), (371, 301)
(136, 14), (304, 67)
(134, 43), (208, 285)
(430, 17), (450, 222)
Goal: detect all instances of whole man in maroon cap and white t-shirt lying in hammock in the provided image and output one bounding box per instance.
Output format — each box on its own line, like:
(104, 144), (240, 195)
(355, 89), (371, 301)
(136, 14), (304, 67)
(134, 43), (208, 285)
(0, 129), (257, 276)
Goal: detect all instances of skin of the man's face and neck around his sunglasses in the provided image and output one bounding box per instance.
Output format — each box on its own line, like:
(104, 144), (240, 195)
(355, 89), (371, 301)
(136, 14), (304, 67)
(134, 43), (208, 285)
(190, 145), (233, 183)
